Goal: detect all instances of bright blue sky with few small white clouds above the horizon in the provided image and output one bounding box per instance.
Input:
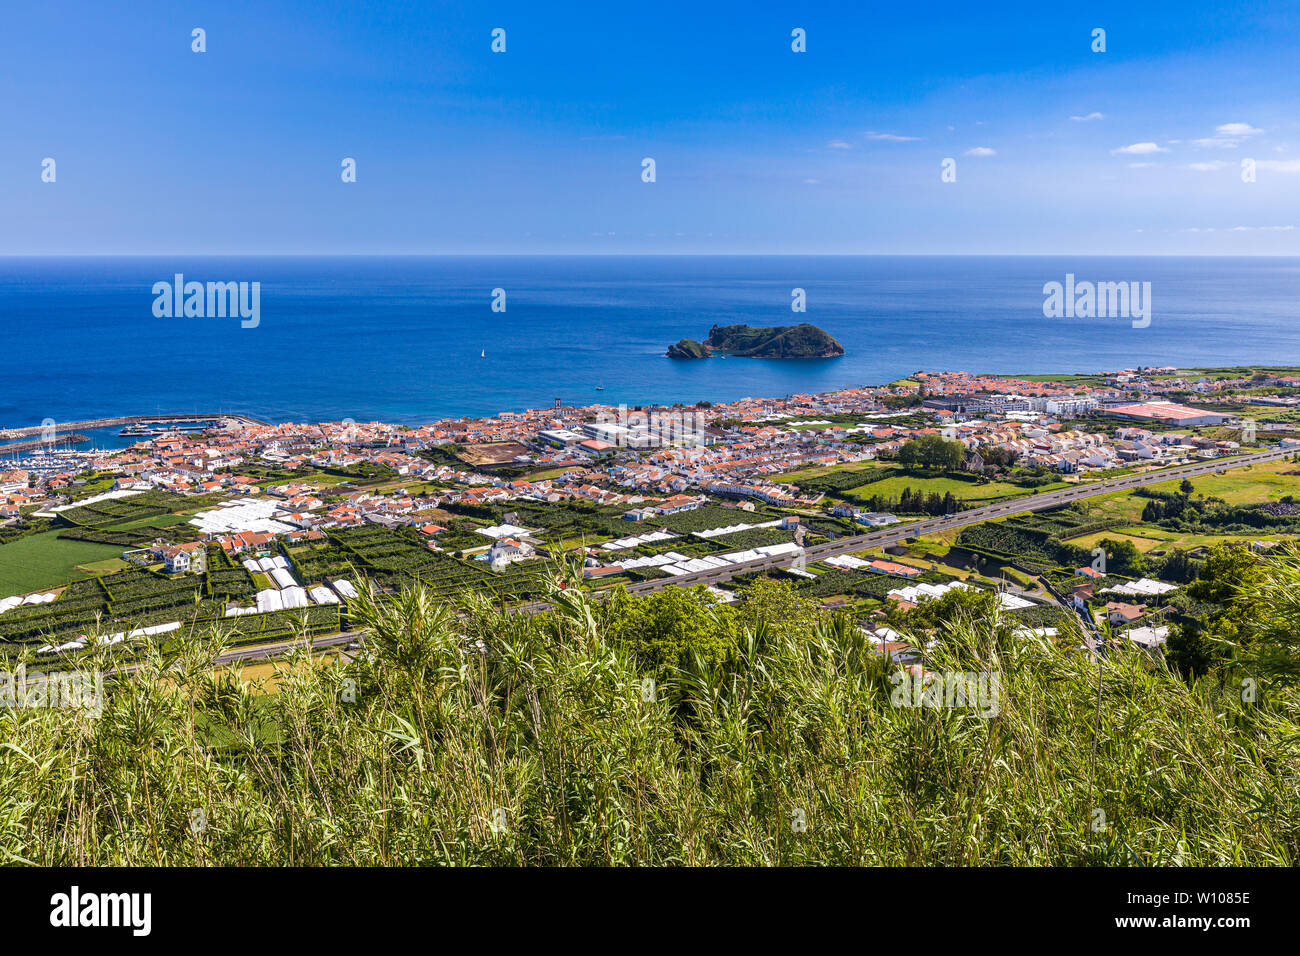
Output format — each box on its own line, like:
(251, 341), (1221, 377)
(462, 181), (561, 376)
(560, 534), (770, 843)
(0, 0), (1300, 255)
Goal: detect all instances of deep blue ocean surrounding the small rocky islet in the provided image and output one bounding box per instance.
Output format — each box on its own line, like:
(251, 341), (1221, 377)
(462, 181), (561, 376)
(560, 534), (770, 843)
(0, 256), (1300, 444)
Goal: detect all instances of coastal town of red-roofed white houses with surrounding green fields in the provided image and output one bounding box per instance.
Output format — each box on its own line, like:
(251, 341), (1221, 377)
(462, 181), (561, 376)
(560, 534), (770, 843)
(0, 368), (1300, 654)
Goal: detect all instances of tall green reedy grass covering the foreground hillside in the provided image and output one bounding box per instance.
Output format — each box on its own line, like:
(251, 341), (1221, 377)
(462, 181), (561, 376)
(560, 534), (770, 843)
(0, 561), (1300, 866)
